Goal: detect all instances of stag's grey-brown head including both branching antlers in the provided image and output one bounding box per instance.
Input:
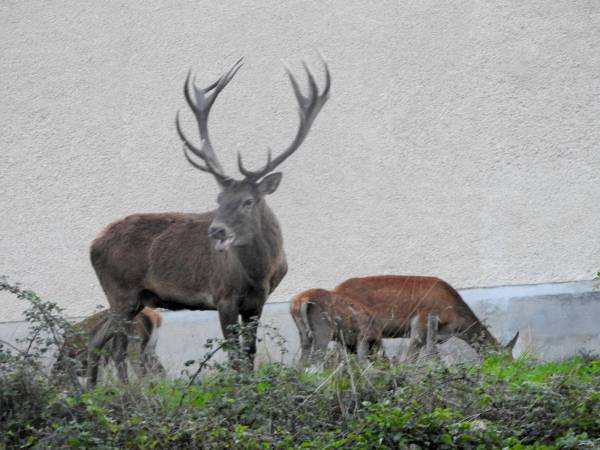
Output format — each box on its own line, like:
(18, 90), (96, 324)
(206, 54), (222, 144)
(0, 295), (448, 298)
(175, 55), (331, 251)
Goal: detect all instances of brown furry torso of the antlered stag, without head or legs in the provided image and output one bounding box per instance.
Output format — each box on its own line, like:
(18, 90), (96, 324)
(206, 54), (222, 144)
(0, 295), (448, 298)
(91, 213), (287, 312)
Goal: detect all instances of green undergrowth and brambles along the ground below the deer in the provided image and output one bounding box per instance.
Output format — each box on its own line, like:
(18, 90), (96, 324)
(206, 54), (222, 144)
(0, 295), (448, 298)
(0, 276), (600, 449)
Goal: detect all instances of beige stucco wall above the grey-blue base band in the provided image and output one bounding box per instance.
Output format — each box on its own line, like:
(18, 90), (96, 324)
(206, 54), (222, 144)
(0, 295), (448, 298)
(0, 0), (600, 320)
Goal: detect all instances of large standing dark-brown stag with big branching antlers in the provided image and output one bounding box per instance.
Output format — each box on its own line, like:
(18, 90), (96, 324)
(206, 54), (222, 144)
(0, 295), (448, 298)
(88, 59), (330, 385)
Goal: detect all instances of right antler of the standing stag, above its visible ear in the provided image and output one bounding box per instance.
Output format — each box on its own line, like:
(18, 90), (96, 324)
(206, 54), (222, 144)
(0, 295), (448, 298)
(238, 54), (331, 180)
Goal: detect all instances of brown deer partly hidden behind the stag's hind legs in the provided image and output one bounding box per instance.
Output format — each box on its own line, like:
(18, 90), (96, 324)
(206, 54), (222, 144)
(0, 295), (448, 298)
(54, 308), (165, 377)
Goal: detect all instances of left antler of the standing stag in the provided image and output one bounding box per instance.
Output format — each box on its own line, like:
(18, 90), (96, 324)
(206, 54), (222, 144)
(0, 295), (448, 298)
(175, 58), (243, 184)
